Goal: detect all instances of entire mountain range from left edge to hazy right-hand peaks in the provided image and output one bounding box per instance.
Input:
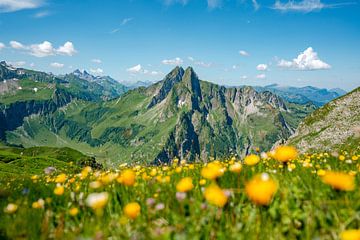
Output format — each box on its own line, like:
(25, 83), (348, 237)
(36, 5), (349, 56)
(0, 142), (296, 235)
(0, 62), (354, 165)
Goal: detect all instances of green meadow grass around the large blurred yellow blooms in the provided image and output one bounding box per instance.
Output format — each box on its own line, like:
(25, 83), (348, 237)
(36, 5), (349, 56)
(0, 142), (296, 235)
(0, 149), (360, 240)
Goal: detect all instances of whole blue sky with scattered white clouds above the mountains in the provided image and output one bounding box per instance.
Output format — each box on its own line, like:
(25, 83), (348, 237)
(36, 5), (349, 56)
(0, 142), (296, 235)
(0, 0), (360, 90)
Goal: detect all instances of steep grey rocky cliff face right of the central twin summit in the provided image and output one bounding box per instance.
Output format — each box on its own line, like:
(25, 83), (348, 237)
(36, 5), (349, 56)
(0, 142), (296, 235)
(151, 68), (304, 163)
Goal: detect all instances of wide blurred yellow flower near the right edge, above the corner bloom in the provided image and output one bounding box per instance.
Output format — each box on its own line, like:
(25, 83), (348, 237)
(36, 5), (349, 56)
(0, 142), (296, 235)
(322, 171), (355, 191)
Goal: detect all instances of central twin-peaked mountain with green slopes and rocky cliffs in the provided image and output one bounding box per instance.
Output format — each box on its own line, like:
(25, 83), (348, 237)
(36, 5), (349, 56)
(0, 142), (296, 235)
(4, 67), (316, 165)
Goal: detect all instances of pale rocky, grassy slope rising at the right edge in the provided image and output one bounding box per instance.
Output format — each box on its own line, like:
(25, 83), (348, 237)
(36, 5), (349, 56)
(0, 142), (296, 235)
(288, 88), (360, 152)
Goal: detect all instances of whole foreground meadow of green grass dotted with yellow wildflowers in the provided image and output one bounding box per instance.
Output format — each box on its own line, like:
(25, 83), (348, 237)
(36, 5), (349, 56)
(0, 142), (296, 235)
(0, 146), (360, 239)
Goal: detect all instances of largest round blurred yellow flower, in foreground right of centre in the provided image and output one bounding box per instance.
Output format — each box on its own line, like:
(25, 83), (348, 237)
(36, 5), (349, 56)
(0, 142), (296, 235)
(245, 173), (277, 205)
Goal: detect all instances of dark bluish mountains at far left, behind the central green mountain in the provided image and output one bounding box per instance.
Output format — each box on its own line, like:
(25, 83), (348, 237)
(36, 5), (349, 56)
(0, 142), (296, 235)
(0, 61), (127, 139)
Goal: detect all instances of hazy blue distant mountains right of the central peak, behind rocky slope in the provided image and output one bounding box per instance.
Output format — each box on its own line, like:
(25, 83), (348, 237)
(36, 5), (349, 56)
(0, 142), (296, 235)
(254, 84), (346, 106)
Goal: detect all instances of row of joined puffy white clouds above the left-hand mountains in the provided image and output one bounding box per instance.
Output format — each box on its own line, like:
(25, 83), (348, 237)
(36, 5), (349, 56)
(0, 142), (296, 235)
(8, 40), (77, 57)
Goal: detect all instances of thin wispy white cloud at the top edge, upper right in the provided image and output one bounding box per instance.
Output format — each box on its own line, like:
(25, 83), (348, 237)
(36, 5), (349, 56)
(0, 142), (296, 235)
(272, 0), (354, 13)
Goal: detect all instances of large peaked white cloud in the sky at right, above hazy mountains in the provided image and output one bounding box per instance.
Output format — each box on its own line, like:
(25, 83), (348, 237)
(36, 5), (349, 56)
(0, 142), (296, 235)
(278, 47), (331, 70)
